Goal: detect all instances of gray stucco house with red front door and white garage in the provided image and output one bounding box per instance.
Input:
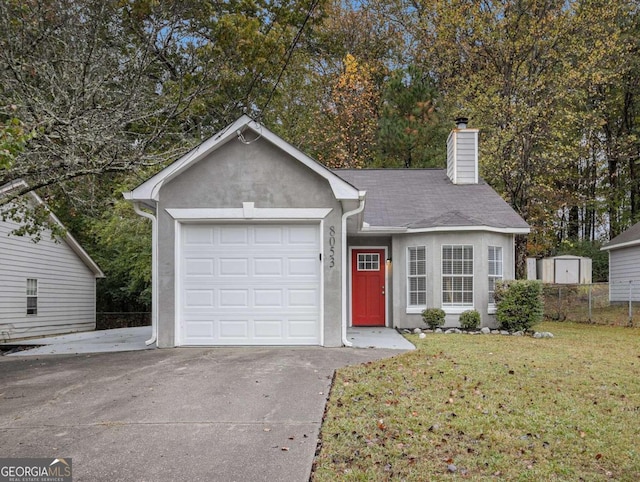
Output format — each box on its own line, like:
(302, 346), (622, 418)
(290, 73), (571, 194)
(125, 116), (529, 347)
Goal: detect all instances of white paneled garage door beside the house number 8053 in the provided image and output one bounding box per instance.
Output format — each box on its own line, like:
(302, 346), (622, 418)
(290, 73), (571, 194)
(178, 224), (321, 345)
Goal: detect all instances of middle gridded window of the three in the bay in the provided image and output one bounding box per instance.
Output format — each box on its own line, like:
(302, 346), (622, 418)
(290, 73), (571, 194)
(442, 245), (473, 306)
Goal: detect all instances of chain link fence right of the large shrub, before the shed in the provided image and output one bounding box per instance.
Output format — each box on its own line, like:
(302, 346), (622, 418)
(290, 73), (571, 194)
(543, 280), (640, 326)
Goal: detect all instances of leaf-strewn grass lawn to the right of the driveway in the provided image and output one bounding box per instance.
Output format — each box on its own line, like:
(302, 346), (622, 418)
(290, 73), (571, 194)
(312, 323), (640, 481)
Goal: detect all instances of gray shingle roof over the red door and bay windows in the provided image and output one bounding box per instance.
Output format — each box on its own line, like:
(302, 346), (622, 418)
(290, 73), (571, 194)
(334, 169), (529, 229)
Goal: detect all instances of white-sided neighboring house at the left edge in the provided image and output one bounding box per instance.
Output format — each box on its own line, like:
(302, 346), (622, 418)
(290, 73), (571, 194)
(0, 181), (104, 341)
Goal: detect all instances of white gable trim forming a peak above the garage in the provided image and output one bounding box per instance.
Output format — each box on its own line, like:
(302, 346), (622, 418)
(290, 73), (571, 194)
(124, 115), (359, 203)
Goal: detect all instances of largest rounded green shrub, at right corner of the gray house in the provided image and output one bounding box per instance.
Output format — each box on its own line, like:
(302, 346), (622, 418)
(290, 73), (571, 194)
(495, 280), (544, 331)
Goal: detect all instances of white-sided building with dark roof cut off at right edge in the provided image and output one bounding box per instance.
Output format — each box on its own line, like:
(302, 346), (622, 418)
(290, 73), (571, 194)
(602, 223), (640, 301)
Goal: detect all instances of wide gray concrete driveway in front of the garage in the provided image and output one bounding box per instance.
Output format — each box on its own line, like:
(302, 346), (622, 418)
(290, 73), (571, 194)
(0, 347), (400, 482)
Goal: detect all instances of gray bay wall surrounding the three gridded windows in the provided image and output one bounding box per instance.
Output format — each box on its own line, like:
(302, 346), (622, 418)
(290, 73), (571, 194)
(392, 231), (514, 328)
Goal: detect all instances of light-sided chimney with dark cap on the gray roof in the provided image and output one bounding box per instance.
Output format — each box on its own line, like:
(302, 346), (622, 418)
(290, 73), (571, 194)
(447, 117), (479, 184)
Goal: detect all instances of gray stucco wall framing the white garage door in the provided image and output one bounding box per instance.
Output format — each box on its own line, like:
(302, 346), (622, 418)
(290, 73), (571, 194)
(158, 138), (342, 347)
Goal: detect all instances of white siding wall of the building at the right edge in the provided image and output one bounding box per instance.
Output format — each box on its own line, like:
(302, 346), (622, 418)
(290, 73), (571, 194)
(609, 246), (640, 301)
